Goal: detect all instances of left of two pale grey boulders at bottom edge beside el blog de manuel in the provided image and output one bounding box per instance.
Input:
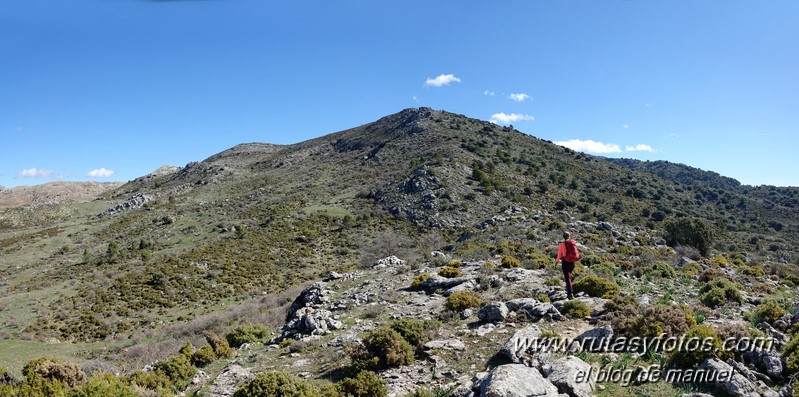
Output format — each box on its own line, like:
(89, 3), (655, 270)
(480, 364), (560, 397)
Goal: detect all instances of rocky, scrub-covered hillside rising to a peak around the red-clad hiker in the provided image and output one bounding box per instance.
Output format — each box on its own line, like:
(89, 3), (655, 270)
(0, 108), (799, 396)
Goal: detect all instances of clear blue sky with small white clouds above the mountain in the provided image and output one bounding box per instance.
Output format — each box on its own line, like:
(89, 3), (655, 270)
(0, 0), (799, 187)
